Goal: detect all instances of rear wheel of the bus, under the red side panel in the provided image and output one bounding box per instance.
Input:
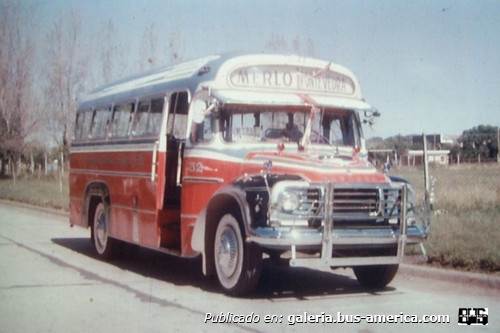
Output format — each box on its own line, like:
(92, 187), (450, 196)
(92, 202), (119, 260)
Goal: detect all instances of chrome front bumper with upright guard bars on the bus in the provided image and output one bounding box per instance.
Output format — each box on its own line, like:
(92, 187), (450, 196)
(247, 184), (427, 267)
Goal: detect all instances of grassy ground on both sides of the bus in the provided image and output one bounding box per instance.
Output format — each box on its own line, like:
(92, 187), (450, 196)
(0, 164), (500, 273)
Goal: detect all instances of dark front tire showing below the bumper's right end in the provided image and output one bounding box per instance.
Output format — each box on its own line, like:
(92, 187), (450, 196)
(353, 265), (399, 289)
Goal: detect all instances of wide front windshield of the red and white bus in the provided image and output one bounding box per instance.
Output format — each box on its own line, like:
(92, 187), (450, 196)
(221, 106), (361, 147)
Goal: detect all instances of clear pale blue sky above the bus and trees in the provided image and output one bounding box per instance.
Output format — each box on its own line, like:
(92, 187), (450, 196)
(32, 0), (500, 138)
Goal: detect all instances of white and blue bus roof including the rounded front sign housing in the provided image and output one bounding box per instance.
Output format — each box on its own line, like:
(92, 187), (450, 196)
(79, 54), (371, 109)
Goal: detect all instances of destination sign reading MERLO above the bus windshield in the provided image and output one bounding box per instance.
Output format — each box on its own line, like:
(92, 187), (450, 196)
(229, 65), (355, 95)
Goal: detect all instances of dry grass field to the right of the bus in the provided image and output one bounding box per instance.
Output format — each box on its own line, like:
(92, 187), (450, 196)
(391, 163), (500, 273)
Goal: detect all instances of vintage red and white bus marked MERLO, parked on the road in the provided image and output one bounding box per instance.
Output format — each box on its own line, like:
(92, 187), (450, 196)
(70, 54), (428, 295)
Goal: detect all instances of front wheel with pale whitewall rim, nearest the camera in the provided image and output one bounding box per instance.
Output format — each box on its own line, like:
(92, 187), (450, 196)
(214, 214), (262, 296)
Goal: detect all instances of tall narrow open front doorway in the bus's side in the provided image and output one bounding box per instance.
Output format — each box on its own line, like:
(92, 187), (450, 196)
(160, 91), (189, 250)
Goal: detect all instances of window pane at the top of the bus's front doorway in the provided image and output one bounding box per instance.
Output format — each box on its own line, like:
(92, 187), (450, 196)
(167, 91), (189, 140)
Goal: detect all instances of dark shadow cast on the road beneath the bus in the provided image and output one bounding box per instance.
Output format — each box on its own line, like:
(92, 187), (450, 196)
(52, 238), (397, 300)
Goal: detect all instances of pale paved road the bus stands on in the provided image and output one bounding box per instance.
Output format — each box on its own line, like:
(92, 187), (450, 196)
(0, 202), (500, 333)
